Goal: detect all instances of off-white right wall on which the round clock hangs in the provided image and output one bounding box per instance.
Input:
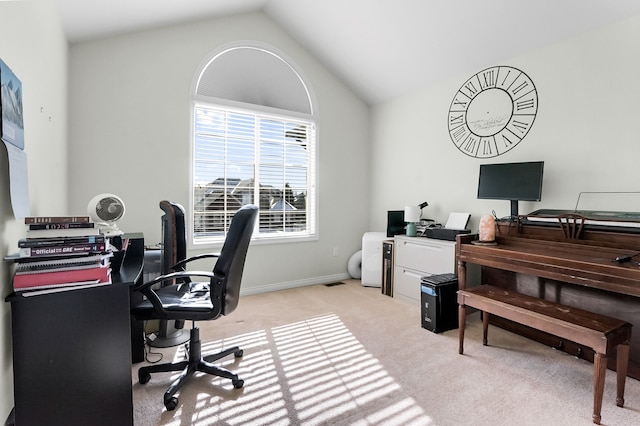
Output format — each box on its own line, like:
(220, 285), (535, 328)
(371, 17), (640, 231)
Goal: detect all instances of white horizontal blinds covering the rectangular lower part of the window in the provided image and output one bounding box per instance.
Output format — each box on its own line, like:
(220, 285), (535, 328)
(193, 103), (316, 244)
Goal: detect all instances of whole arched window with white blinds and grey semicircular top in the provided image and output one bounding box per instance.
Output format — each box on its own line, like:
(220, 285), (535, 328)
(191, 43), (316, 244)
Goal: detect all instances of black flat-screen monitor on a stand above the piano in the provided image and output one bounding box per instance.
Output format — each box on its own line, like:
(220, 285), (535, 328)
(478, 161), (544, 219)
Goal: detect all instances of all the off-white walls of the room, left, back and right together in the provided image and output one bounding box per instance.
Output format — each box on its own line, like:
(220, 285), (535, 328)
(5, 5), (640, 417)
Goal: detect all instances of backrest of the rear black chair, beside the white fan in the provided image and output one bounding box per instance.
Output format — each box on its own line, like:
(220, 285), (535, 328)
(160, 200), (187, 275)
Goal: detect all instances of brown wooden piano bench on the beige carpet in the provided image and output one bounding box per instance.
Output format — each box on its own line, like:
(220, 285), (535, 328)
(458, 285), (631, 424)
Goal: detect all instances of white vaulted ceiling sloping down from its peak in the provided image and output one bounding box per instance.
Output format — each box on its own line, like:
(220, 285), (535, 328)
(55, 0), (640, 104)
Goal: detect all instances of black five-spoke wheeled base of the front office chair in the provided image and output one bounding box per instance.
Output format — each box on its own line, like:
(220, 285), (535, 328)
(138, 326), (244, 411)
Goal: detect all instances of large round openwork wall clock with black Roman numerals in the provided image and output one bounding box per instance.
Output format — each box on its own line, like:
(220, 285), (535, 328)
(449, 66), (538, 158)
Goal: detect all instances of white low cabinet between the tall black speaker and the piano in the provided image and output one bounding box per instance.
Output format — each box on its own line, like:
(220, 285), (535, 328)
(393, 235), (456, 305)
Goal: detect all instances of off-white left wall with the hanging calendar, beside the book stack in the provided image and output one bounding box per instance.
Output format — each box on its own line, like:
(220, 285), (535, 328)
(0, 0), (67, 422)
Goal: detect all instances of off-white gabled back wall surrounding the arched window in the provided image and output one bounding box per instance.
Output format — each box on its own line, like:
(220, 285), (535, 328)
(69, 13), (369, 293)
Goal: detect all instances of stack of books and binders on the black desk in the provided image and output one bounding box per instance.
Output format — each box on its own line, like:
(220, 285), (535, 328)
(13, 216), (112, 292)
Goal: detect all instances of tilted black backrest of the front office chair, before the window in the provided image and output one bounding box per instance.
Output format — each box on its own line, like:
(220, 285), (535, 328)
(211, 204), (258, 315)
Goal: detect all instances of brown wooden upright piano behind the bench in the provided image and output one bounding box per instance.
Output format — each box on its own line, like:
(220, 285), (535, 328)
(456, 216), (640, 379)
